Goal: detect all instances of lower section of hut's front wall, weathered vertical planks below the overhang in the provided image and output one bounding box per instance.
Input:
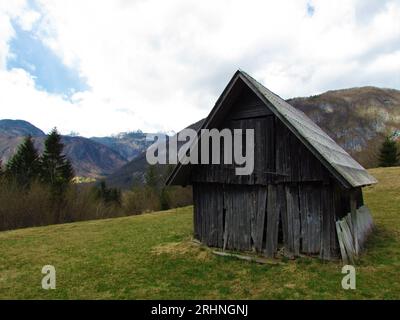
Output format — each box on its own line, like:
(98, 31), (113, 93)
(193, 183), (354, 259)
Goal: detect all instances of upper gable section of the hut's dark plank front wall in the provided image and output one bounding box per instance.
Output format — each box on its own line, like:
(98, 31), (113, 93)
(191, 89), (331, 185)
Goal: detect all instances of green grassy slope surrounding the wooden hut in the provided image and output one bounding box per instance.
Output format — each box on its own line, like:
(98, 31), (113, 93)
(0, 168), (400, 299)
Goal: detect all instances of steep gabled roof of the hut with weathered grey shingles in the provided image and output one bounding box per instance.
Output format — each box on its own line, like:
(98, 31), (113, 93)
(167, 70), (377, 188)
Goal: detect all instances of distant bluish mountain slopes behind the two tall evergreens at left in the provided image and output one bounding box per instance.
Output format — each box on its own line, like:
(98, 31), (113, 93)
(0, 120), (127, 178)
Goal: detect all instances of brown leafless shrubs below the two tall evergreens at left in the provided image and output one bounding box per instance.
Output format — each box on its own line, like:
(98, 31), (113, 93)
(0, 179), (123, 230)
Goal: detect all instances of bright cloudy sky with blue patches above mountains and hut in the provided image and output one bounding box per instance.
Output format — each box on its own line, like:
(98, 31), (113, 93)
(0, 0), (400, 136)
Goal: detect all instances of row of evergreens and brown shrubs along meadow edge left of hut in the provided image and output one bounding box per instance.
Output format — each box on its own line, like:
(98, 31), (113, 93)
(0, 129), (192, 230)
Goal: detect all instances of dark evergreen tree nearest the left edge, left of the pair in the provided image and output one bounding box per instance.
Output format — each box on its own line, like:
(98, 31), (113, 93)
(6, 136), (40, 188)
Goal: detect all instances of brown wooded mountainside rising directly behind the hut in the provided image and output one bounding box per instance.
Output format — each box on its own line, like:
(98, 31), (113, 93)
(107, 87), (400, 188)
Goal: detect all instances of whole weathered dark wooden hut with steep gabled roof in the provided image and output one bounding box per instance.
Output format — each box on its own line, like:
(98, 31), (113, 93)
(167, 70), (376, 259)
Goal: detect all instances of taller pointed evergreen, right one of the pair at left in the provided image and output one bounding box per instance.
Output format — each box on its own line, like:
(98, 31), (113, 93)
(40, 128), (74, 193)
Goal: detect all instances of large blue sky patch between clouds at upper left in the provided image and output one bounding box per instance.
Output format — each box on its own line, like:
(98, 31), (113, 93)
(7, 23), (89, 97)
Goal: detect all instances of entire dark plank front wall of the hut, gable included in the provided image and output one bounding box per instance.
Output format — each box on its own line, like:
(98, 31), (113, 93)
(191, 85), (363, 259)
